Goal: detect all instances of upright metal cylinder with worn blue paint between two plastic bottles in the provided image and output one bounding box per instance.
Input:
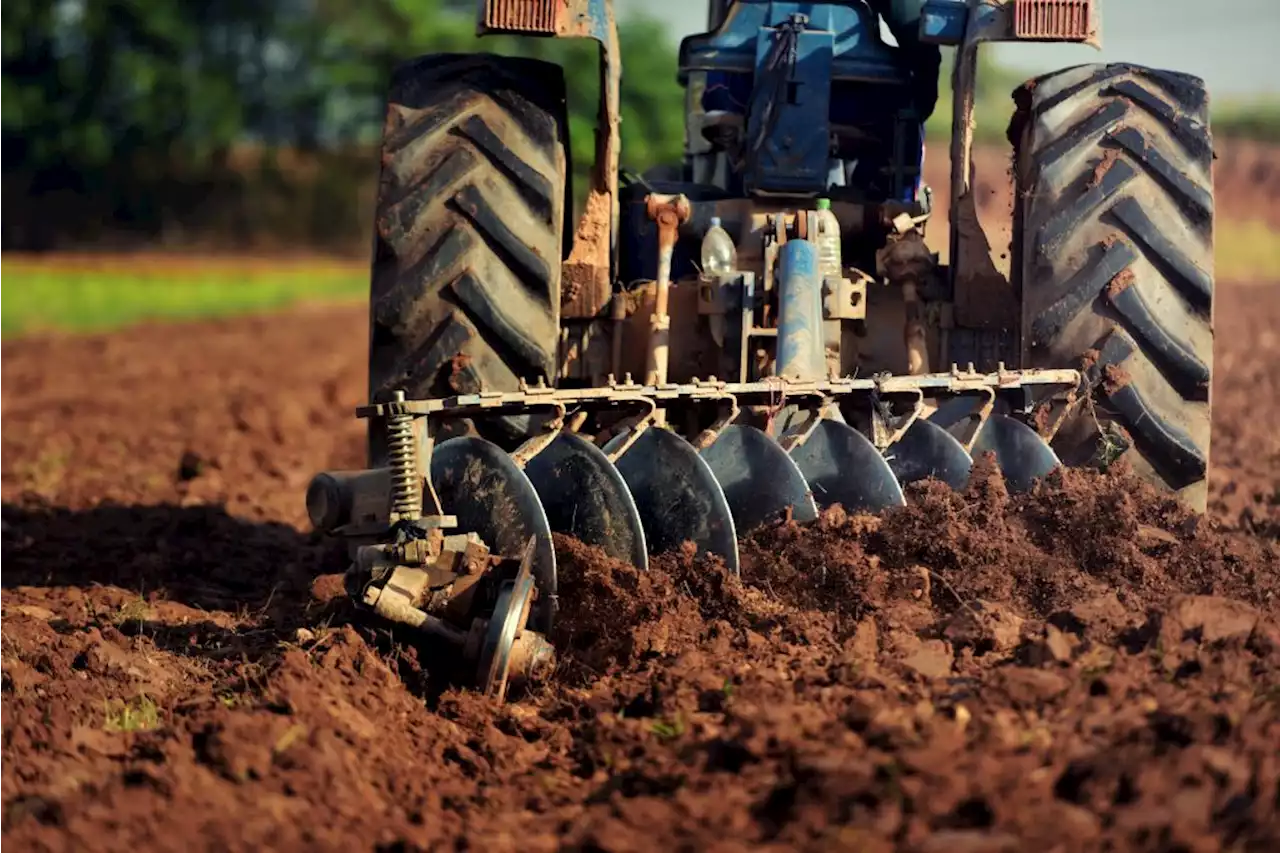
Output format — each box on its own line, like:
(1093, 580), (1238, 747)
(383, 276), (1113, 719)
(777, 238), (827, 380)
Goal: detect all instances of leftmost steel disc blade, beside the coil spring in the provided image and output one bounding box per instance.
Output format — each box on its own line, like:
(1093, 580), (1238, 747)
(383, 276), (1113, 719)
(431, 435), (556, 633)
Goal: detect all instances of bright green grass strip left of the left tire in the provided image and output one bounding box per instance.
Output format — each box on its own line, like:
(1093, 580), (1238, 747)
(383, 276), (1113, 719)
(0, 259), (369, 337)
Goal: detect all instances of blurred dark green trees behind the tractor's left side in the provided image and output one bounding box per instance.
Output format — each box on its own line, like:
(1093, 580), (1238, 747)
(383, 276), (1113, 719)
(0, 0), (682, 247)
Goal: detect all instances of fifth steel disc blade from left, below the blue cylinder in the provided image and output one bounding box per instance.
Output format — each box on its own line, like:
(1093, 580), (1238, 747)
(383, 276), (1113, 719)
(791, 419), (906, 512)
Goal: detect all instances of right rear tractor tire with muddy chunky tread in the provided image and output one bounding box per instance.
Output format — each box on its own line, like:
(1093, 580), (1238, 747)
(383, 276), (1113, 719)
(1010, 64), (1213, 511)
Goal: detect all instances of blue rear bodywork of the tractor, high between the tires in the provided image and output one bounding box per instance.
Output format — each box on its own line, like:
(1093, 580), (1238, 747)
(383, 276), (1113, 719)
(680, 1), (923, 201)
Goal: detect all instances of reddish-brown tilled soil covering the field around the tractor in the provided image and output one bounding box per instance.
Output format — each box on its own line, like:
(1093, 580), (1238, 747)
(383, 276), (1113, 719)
(0, 281), (1280, 853)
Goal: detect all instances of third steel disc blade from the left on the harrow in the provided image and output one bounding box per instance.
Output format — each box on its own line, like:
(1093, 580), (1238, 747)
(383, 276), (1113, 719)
(604, 427), (737, 574)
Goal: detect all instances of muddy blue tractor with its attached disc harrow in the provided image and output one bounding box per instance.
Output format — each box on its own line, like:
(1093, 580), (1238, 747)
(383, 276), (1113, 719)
(306, 0), (1213, 699)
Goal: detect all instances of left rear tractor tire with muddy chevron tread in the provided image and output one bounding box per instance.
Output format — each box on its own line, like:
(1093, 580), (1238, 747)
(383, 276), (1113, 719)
(369, 54), (570, 465)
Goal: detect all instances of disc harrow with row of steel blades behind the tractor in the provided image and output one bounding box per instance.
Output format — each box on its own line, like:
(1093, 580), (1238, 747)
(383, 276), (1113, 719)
(307, 368), (1083, 697)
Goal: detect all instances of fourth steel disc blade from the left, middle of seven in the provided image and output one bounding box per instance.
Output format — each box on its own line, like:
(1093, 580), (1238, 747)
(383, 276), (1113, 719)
(701, 424), (818, 534)
